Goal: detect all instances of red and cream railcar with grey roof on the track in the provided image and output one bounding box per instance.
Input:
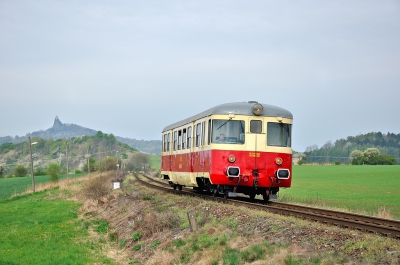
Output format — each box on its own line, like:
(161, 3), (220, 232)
(161, 101), (293, 200)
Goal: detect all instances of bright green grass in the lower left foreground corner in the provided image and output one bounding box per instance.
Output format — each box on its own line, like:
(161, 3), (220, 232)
(0, 189), (113, 265)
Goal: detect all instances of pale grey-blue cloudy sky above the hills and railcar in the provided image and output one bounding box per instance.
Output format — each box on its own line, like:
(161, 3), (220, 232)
(0, 0), (400, 151)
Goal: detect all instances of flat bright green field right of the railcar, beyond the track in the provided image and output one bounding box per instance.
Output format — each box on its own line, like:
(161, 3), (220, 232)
(279, 165), (400, 219)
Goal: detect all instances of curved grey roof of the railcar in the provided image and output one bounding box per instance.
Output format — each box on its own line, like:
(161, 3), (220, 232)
(163, 101), (293, 132)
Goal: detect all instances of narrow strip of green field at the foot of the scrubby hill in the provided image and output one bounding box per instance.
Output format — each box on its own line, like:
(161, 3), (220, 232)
(0, 173), (86, 201)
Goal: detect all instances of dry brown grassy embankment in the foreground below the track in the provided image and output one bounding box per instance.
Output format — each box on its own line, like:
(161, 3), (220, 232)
(81, 173), (400, 264)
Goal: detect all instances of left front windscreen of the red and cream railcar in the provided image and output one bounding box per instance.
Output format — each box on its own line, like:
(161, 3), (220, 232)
(211, 119), (244, 144)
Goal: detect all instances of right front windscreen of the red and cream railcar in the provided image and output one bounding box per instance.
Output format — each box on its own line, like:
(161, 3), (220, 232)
(267, 122), (292, 147)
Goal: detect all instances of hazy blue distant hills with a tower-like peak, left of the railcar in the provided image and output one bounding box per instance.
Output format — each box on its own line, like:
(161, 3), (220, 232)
(0, 116), (161, 155)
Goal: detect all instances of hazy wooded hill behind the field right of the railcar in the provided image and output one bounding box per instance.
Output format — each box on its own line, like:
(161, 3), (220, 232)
(303, 132), (400, 164)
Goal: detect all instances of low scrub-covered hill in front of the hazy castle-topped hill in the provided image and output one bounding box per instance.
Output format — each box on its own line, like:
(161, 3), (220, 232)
(0, 131), (138, 173)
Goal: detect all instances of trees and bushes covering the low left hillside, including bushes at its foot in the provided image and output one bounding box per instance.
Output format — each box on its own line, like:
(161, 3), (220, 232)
(0, 131), (150, 179)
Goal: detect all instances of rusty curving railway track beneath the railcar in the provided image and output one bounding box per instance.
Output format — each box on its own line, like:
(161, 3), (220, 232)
(135, 174), (400, 239)
